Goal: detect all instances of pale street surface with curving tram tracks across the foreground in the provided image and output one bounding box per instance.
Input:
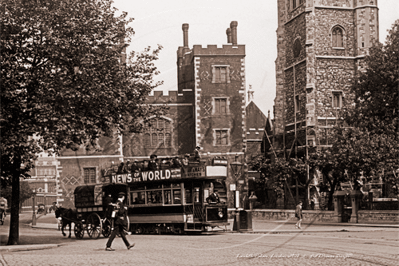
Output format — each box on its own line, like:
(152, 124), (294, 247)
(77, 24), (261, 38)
(0, 214), (399, 265)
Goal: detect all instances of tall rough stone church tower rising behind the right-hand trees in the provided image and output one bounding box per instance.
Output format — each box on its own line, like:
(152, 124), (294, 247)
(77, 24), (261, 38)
(274, 0), (378, 156)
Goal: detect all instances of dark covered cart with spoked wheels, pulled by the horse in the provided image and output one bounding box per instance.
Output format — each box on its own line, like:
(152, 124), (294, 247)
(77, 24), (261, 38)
(74, 184), (129, 239)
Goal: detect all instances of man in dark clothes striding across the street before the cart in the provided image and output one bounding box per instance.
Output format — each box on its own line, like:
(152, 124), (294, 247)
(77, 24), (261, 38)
(105, 192), (134, 251)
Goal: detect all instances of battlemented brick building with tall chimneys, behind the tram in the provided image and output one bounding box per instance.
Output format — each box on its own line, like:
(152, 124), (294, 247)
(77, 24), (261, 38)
(51, 21), (265, 206)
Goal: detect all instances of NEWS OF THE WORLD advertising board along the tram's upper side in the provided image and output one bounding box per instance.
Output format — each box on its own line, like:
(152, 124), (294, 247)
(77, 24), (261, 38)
(109, 166), (206, 184)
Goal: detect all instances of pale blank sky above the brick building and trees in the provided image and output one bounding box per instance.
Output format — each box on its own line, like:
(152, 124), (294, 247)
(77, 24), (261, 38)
(114, 0), (399, 117)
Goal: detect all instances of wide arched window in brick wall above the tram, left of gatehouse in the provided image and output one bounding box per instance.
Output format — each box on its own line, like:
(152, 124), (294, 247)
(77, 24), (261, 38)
(143, 117), (172, 148)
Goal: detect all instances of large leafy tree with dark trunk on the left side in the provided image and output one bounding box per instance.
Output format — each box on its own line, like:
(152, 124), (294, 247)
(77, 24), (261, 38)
(0, 0), (161, 245)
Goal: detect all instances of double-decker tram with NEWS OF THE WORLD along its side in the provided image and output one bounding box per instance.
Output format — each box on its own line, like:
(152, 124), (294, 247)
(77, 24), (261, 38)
(105, 159), (229, 234)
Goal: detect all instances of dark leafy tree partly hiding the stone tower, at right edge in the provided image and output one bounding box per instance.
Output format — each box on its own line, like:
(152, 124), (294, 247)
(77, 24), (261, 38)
(310, 20), (399, 208)
